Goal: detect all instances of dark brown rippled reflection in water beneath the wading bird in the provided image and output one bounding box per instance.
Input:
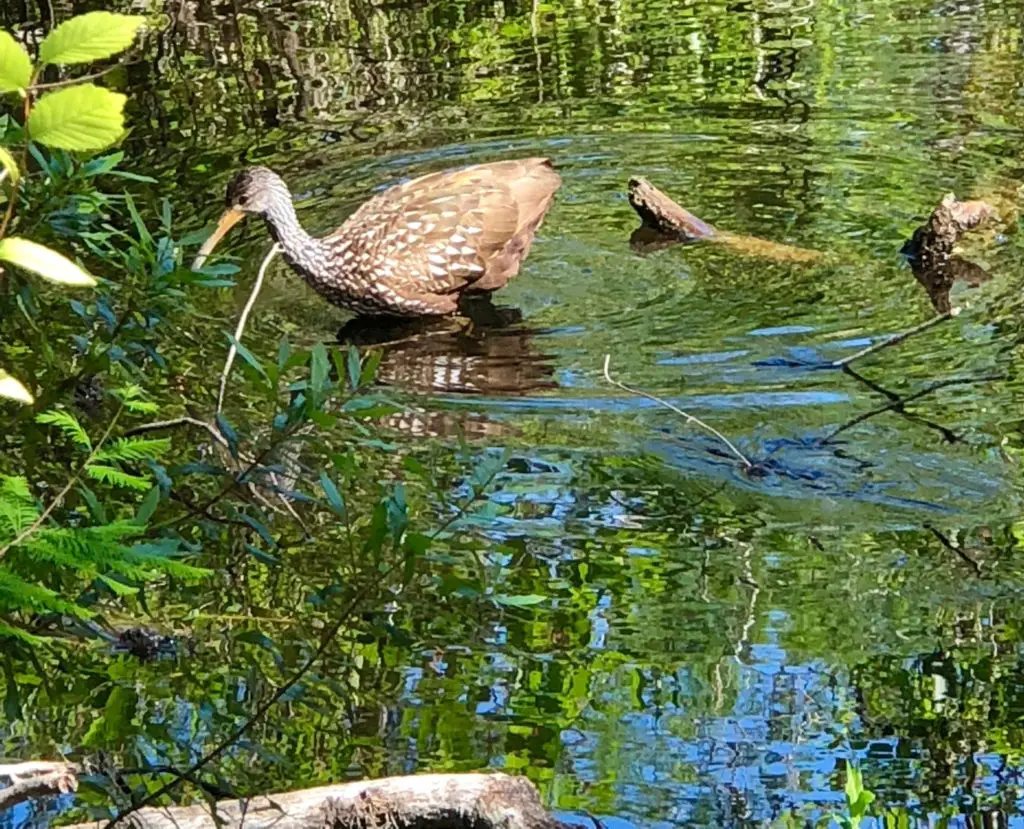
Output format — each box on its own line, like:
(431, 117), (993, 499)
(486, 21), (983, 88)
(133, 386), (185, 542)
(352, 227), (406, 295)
(338, 298), (557, 437)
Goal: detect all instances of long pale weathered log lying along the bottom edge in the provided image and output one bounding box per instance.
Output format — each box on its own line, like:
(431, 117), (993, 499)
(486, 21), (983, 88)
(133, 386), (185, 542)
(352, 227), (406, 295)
(58, 774), (564, 829)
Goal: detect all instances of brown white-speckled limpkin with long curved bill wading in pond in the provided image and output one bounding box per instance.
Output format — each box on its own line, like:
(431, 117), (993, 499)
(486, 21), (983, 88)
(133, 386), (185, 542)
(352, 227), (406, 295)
(194, 159), (561, 317)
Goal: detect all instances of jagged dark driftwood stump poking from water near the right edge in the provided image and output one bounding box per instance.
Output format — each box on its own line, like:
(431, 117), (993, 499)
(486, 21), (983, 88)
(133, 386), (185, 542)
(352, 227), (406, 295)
(902, 193), (995, 314)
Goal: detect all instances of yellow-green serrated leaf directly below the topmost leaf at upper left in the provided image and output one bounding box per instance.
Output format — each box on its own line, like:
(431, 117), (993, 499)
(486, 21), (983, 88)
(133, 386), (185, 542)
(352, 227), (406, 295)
(28, 84), (126, 149)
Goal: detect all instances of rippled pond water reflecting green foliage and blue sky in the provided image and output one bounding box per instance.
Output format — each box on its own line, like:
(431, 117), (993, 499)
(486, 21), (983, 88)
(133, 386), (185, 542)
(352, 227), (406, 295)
(6, 0), (1024, 829)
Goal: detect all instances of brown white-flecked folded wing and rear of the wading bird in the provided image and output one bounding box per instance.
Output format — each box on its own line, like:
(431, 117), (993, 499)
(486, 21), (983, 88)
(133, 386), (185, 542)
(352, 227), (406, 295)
(328, 159), (560, 302)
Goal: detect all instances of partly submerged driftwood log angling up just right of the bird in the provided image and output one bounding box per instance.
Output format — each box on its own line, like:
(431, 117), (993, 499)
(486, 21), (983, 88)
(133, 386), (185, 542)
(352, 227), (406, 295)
(629, 176), (822, 262)
